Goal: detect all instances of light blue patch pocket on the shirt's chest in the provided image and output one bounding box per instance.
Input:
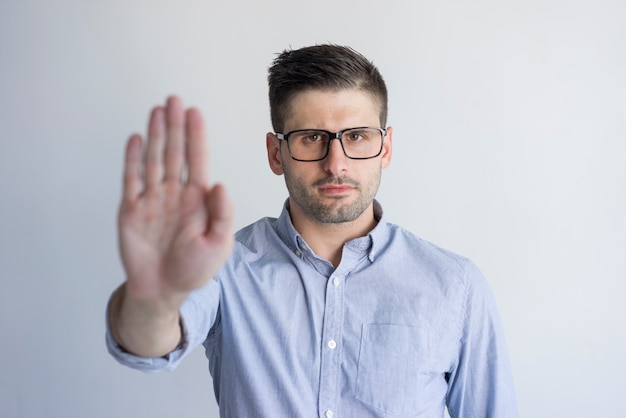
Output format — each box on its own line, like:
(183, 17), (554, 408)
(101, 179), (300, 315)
(355, 324), (447, 416)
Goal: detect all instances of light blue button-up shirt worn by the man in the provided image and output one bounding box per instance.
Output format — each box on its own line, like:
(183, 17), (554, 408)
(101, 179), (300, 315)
(107, 202), (517, 418)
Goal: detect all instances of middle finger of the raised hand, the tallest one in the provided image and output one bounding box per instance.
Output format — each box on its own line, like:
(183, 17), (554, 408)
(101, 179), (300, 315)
(165, 96), (185, 185)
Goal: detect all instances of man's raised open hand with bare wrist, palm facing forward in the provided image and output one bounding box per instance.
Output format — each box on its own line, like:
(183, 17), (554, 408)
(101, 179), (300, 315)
(108, 97), (233, 357)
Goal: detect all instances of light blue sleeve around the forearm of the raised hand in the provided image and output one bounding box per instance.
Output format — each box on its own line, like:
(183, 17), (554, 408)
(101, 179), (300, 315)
(106, 280), (220, 373)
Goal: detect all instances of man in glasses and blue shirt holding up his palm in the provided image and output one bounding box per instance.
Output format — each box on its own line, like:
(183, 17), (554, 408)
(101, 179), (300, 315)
(107, 45), (517, 418)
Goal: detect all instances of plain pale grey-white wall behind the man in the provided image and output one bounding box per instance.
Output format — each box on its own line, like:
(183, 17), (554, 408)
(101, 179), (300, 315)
(0, 0), (626, 418)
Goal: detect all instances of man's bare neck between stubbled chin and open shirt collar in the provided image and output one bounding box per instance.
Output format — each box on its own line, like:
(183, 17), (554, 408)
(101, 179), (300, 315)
(289, 200), (378, 267)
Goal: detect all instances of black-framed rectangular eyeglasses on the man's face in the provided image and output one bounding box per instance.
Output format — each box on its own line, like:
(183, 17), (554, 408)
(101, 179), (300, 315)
(276, 127), (387, 161)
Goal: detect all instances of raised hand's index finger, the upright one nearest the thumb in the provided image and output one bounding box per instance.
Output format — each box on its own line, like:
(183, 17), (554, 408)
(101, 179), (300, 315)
(185, 108), (208, 186)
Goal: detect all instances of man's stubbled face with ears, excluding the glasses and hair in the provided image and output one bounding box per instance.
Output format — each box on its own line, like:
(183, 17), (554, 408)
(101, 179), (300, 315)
(267, 89), (391, 223)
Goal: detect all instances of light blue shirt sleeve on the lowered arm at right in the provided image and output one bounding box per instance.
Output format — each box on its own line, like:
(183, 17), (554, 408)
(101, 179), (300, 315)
(447, 263), (518, 418)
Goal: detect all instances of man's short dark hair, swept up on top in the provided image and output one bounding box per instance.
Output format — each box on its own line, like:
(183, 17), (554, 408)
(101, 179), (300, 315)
(268, 45), (387, 132)
